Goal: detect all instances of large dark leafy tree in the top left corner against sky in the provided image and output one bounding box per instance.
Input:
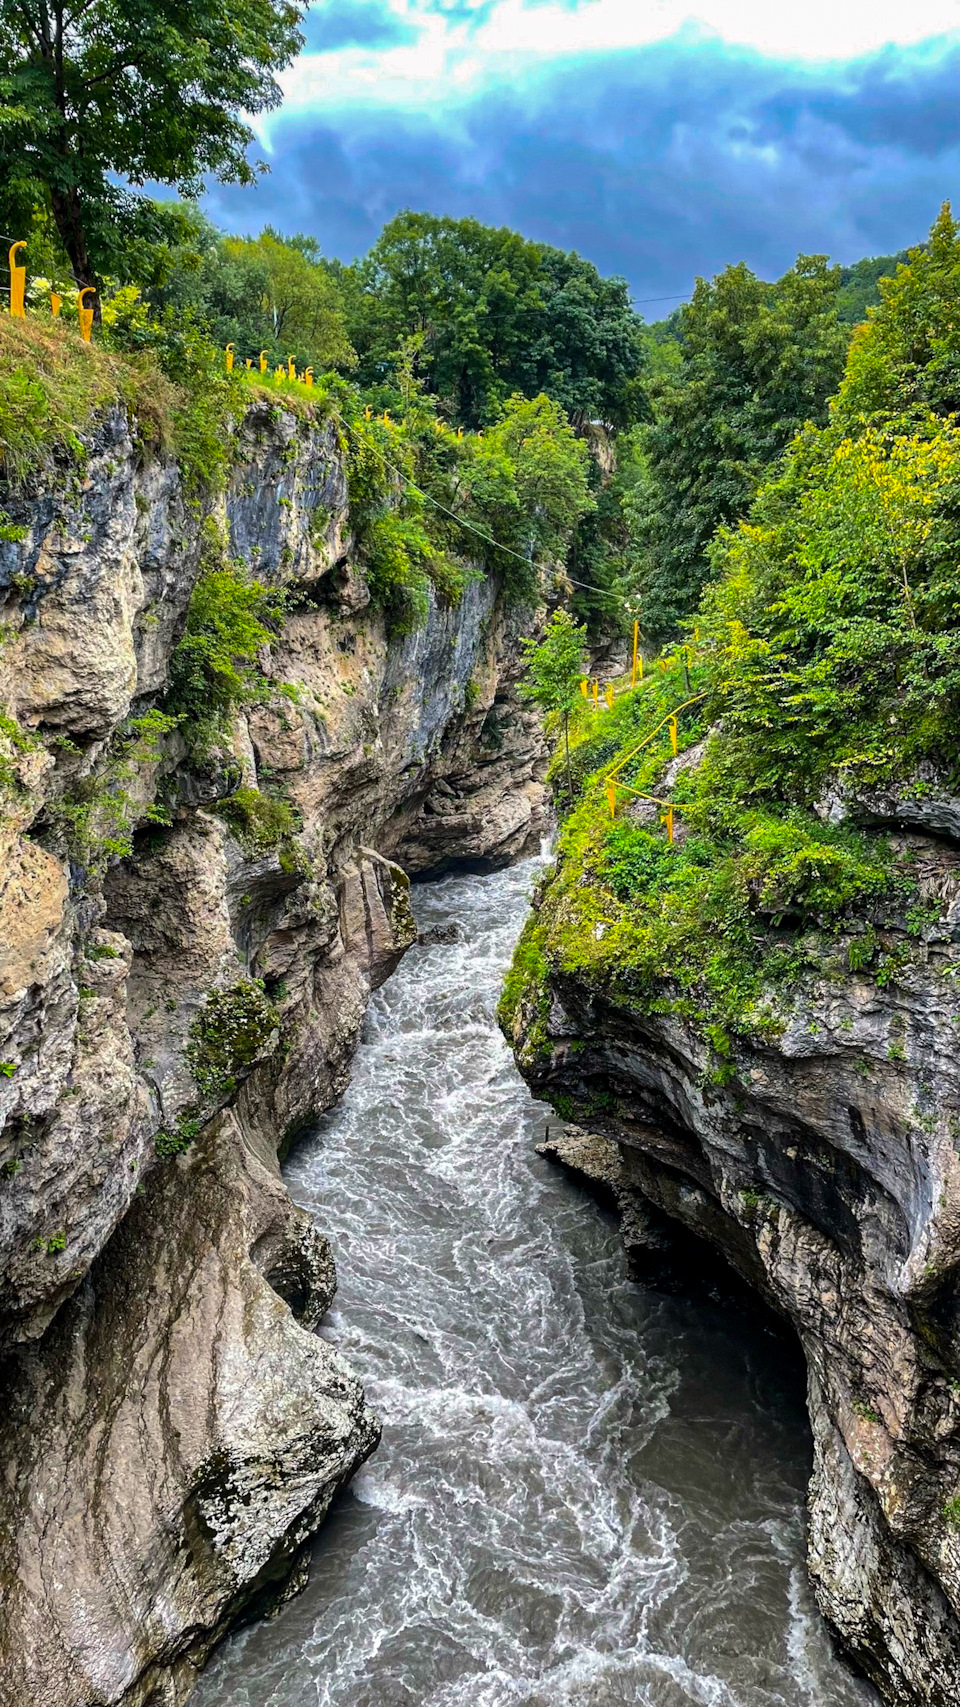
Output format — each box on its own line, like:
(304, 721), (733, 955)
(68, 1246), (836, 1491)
(0, 0), (304, 285)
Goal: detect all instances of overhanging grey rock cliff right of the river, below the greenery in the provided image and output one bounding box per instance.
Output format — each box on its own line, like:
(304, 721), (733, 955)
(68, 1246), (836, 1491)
(514, 809), (960, 1707)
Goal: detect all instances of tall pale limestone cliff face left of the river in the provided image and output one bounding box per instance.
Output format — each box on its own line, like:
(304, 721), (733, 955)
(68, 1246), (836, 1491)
(0, 392), (543, 1707)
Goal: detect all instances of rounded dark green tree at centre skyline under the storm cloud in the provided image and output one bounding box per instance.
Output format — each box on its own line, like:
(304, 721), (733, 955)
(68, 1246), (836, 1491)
(331, 212), (644, 427)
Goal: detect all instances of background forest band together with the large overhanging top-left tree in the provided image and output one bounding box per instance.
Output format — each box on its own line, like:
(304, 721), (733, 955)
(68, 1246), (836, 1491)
(0, 0), (922, 644)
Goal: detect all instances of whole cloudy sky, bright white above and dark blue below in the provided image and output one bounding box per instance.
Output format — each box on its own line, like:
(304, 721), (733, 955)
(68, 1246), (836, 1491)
(199, 0), (960, 303)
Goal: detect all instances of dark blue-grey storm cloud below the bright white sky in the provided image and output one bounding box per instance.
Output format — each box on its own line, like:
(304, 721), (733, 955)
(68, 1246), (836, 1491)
(203, 41), (960, 297)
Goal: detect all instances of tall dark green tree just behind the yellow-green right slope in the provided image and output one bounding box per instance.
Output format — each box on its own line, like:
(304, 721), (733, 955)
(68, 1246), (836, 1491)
(629, 256), (849, 635)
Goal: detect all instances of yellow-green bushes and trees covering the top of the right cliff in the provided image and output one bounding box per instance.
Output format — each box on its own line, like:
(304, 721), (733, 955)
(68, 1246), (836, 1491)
(511, 210), (960, 1079)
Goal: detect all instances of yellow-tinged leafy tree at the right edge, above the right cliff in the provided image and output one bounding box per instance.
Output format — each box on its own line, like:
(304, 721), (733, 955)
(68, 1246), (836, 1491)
(699, 208), (960, 804)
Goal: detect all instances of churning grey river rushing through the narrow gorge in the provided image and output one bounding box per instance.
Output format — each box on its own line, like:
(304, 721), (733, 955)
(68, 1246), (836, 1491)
(195, 862), (875, 1707)
